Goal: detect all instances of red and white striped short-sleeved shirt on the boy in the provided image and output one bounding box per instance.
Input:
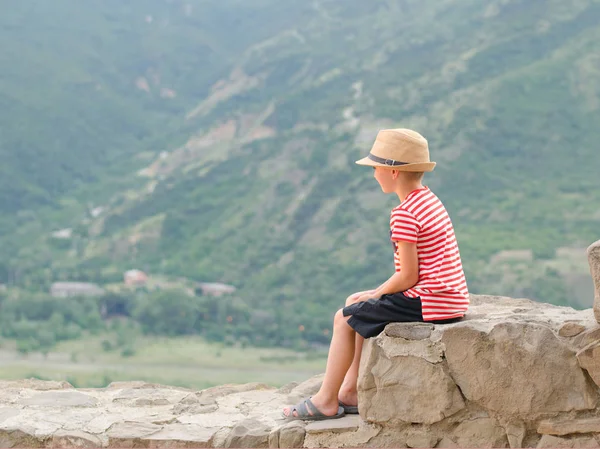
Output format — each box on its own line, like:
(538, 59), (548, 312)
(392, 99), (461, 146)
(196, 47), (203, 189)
(390, 187), (469, 321)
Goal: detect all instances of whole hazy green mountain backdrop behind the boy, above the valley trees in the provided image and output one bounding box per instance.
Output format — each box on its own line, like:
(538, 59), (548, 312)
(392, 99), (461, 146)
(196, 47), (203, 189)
(0, 0), (600, 338)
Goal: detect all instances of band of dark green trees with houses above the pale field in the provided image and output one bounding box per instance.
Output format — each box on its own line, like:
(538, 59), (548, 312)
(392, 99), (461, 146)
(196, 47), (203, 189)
(0, 289), (318, 356)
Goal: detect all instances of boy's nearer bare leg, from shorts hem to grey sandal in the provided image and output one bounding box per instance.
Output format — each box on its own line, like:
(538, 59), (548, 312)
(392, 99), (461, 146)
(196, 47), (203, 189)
(284, 309), (356, 416)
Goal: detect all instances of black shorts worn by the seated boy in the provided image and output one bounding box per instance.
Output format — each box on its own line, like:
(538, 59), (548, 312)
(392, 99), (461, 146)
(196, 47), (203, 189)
(342, 293), (462, 338)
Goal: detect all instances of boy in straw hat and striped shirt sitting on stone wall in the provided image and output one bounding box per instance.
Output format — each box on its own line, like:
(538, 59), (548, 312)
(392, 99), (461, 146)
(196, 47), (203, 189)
(283, 129), (469, 420)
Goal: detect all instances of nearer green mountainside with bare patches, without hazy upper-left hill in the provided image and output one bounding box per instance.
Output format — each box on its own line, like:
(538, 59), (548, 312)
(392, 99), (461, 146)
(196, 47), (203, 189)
(0, 0), (600, 344)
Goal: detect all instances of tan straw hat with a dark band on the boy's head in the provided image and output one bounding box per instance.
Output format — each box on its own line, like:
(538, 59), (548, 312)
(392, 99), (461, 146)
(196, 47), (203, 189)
(356, 129), (435, 172)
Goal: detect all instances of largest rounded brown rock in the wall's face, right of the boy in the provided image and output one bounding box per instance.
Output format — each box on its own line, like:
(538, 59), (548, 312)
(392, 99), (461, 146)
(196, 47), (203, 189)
(442, 322), (598, 419)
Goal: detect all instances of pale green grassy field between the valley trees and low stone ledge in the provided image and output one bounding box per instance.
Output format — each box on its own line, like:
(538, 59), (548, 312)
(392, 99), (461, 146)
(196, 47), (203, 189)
(0, 336), (325, 389)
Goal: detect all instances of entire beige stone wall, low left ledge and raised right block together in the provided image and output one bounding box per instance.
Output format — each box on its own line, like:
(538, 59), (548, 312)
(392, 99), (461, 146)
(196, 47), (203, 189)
(0, 295), (600, 447)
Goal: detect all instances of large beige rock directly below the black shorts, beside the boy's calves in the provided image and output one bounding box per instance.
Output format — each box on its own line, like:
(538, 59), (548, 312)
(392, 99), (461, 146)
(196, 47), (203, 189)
(358, 335), (465, 424)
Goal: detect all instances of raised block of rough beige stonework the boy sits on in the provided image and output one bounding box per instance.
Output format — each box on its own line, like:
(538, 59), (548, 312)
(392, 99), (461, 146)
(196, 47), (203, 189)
(359, 296), (600, 447)
